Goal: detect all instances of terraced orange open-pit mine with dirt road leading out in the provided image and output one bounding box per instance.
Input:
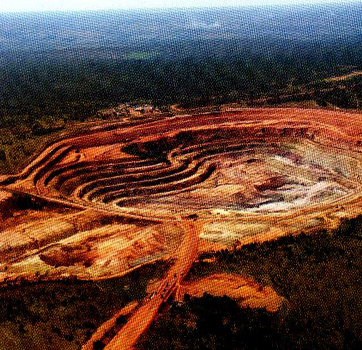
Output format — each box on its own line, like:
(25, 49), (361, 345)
(0, 108), (362, 348)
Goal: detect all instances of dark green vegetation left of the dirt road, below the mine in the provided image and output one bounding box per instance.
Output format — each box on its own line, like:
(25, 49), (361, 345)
(0, 263), (168, 350)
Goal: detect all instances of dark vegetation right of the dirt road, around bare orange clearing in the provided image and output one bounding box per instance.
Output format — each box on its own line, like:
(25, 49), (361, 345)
(138, 216), (362, 349)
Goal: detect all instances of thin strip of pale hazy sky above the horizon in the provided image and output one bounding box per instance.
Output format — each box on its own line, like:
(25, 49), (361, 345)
(0, 0), (362, 12)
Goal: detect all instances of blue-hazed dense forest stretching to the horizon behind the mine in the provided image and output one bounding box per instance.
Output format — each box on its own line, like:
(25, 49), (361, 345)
(0, 4), (362, 119)
